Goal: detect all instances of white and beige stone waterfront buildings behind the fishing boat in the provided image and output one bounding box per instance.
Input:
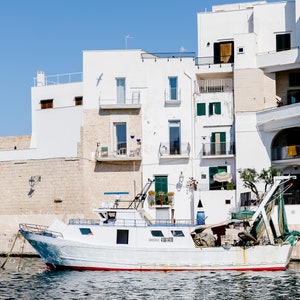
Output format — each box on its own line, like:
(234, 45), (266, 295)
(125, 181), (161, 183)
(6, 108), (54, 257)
(0, 0), (300, 255)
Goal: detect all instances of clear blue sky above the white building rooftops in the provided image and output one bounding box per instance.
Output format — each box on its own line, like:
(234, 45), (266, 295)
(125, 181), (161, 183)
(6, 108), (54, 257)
(0, 0), (276, 136)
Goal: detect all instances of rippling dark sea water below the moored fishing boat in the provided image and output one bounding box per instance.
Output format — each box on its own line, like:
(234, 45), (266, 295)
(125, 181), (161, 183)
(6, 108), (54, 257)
(0, 257), (300, 300)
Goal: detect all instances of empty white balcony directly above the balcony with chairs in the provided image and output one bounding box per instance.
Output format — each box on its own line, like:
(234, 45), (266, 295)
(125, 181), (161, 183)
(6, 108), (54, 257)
(99, 91), (141, 110)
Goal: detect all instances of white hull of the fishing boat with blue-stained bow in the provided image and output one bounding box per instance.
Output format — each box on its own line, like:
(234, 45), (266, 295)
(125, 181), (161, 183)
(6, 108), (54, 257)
(20, 231), (293, 271)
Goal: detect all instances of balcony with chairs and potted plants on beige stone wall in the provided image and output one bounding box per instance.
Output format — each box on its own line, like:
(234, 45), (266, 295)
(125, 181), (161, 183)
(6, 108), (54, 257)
(95, 147), (142, 162)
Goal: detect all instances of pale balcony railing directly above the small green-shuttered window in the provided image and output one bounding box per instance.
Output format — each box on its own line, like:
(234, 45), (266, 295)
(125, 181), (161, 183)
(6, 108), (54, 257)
(195, 78), (233, 94)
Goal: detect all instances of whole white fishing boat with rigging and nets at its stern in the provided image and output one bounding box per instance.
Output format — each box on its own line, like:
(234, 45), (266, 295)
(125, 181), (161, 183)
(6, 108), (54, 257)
(19, 176), (299, 271)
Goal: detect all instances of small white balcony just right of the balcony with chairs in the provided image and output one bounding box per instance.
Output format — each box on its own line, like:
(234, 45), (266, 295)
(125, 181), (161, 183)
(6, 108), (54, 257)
(159, 142), (191, 159)
